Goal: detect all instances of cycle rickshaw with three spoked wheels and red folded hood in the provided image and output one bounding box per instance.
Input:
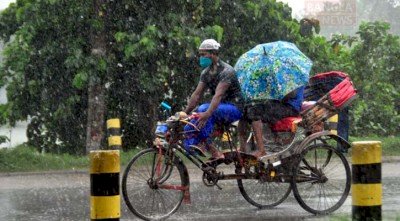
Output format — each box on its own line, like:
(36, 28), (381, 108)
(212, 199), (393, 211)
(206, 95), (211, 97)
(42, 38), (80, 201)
(122, 72), (356, 220)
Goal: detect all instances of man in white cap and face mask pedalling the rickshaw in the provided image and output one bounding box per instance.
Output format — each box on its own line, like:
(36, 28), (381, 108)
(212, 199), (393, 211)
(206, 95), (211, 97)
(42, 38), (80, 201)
(184, 39), (243, 159)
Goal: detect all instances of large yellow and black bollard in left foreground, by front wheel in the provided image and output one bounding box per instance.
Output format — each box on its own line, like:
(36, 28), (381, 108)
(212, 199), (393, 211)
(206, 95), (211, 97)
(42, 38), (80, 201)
(90, 150), (121, 220)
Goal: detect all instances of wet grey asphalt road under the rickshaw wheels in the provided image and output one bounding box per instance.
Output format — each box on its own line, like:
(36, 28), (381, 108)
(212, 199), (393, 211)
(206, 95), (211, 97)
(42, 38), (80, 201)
(0, 162), (400, 221)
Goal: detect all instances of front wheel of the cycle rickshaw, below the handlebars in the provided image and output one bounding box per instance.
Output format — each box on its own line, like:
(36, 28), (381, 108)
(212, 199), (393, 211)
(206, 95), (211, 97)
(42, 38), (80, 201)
(122, 149), (188, 219)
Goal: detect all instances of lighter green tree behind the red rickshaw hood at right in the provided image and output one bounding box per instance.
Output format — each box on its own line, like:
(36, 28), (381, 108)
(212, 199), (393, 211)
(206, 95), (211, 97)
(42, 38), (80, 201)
(300, 22), (400, 136)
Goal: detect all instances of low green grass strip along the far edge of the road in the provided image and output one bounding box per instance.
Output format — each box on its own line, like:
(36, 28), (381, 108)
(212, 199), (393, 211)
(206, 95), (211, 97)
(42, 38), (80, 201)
(0, 136), (400, 173)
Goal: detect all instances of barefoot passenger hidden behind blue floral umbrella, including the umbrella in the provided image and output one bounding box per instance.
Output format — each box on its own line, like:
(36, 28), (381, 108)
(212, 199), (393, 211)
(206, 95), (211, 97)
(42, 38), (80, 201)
(235, 41), (312, 158)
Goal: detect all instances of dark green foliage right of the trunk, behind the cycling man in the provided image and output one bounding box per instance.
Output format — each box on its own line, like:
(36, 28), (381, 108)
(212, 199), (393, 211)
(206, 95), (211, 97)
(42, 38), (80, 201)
(109, 1), (300, 150)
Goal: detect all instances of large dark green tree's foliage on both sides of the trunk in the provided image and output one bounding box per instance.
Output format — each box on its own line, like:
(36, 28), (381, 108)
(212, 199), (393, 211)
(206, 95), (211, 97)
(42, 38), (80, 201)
(0, 0), (300, 153)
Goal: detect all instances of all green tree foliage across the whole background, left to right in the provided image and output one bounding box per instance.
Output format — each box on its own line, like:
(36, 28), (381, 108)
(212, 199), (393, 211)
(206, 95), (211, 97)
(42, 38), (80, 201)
(0, 0), (399, 154)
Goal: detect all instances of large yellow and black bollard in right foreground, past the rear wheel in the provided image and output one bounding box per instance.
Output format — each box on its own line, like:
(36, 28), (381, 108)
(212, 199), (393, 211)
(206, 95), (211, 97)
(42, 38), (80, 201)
(351, 141), (382, 221)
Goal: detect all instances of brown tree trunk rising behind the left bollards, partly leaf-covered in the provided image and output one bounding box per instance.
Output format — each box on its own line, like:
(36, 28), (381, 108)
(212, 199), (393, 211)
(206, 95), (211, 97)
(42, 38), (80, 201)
(86, 0), (107, 153)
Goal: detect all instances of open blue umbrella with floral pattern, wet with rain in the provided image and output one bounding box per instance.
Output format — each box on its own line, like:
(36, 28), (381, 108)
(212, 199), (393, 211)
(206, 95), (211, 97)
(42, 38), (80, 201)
(235, 41), (312, 101)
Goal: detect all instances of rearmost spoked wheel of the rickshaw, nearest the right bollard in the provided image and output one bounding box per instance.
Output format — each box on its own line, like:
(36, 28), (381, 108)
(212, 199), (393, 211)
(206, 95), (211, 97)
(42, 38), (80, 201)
(292, 143), (351, 214)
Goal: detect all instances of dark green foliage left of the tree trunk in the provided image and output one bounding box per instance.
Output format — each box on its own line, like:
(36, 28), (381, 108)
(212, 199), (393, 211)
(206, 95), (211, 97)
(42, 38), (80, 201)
(0, 0), (90, 155)
